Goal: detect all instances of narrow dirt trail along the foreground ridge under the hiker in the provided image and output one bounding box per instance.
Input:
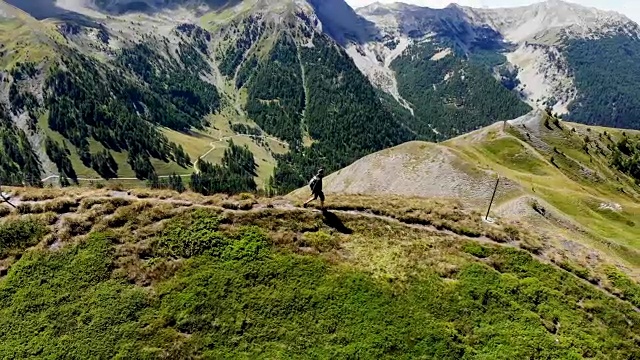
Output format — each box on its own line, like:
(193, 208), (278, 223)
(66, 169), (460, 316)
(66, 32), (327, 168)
(10, 191), (640, 313)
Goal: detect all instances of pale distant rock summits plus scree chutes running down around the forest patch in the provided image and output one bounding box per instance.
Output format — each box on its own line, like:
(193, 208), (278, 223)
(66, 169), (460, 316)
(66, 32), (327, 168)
(358, 0), (640, 118)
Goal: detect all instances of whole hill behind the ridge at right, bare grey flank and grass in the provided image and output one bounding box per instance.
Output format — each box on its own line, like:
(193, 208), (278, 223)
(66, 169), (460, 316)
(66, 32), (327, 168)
(300, 112), (640, 273)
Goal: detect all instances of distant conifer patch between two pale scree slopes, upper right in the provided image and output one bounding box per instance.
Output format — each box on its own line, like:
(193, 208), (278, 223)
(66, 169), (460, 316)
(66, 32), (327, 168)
(392, 43), (531, 140)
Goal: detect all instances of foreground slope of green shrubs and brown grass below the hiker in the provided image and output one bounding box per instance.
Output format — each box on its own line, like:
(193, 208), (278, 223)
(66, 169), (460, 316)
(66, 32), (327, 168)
(0, 188), (640, 359)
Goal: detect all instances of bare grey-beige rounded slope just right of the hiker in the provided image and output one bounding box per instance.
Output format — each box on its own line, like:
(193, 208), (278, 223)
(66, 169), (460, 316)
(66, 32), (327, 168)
(325, 142), (519, 205)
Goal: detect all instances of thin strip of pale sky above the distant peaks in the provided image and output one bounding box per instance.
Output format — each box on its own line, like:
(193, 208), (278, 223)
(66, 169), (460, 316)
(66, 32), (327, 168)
(346, 0), (640, 23)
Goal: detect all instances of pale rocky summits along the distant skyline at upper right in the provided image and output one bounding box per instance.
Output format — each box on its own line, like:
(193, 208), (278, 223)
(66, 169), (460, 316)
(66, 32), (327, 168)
(357, 0), (640, 43)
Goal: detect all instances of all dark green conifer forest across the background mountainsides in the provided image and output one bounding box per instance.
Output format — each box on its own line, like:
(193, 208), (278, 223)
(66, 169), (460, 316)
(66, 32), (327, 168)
(5, 14), (640, 197)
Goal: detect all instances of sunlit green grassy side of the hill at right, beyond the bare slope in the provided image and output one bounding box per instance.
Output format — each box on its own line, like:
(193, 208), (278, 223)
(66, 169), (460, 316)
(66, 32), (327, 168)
(445, 112), (640, 266)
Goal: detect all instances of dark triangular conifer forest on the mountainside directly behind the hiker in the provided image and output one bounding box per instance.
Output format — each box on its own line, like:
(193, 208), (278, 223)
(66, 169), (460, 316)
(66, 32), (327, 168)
(256, 36), (414, 193)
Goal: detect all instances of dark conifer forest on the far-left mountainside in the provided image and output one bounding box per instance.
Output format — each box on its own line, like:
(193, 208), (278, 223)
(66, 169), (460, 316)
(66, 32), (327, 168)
(3, 27), (215, 183)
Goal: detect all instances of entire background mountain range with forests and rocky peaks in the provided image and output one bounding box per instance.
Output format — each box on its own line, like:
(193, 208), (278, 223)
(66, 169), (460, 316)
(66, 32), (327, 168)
(0, 0), (640, 192)
